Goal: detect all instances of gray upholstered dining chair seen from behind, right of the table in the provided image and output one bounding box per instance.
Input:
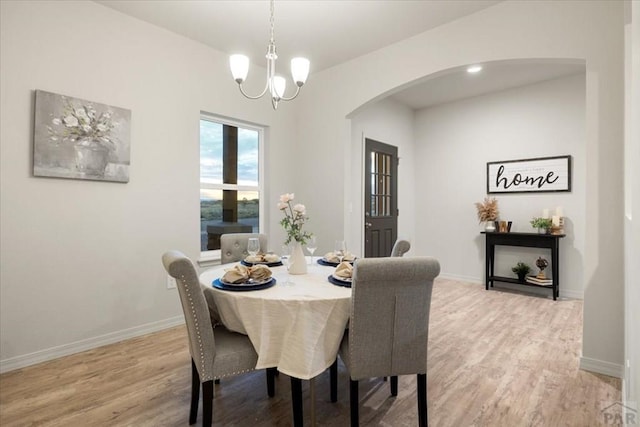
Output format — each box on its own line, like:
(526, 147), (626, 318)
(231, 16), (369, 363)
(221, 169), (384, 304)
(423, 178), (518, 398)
(339, 257), (440, 427)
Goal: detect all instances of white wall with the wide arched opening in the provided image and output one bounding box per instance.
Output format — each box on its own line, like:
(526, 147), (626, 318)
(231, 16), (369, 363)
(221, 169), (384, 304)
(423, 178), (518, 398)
(297, 1), (624, 376)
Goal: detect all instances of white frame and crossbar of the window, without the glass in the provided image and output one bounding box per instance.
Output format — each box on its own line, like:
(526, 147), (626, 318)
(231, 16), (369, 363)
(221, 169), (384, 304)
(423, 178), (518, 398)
(198, 112), (265, 265)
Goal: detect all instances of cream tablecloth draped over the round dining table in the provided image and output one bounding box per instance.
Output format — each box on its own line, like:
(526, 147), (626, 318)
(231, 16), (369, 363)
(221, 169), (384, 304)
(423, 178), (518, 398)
(200, 264), (351, 380)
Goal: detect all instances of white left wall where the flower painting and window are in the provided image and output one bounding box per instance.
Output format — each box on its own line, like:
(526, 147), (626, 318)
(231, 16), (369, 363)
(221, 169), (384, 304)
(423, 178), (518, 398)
(0, 1), (296, 371)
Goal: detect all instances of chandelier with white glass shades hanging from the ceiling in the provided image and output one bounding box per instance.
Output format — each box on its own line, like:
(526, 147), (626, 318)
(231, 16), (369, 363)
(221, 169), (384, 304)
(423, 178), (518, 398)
(229, 0), (309, 110)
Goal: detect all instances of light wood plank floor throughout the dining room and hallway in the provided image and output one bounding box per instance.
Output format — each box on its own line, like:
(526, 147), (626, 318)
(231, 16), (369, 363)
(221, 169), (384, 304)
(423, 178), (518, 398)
(0, 279), (621, 427)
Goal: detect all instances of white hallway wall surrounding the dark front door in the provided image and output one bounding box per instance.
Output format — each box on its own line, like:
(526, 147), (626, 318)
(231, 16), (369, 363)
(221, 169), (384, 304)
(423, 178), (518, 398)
(345, 99), (416, 254)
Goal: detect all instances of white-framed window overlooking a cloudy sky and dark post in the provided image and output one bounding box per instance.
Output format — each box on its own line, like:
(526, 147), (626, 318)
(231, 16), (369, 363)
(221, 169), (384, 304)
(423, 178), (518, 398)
(200, 115), (264, 252)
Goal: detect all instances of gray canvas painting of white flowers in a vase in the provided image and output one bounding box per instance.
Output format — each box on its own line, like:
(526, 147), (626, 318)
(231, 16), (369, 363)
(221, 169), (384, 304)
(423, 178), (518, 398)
(33, 90), (131, 182)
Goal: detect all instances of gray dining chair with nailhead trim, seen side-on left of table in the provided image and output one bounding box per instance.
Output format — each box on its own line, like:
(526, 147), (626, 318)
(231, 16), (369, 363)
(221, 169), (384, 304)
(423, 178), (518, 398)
(162, 251), (274, 426)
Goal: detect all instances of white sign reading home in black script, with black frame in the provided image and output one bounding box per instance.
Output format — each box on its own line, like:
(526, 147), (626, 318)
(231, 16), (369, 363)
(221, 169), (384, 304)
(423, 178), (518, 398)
(487, 156), (571, 194)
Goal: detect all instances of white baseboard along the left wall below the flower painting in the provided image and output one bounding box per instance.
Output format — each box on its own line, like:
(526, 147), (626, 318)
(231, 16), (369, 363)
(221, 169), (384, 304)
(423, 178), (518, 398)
(0, 316), (184, 374)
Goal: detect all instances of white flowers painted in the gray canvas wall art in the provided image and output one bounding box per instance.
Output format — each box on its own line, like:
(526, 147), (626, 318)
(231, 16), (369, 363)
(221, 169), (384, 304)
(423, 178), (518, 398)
(47, 98), (116, 151)
